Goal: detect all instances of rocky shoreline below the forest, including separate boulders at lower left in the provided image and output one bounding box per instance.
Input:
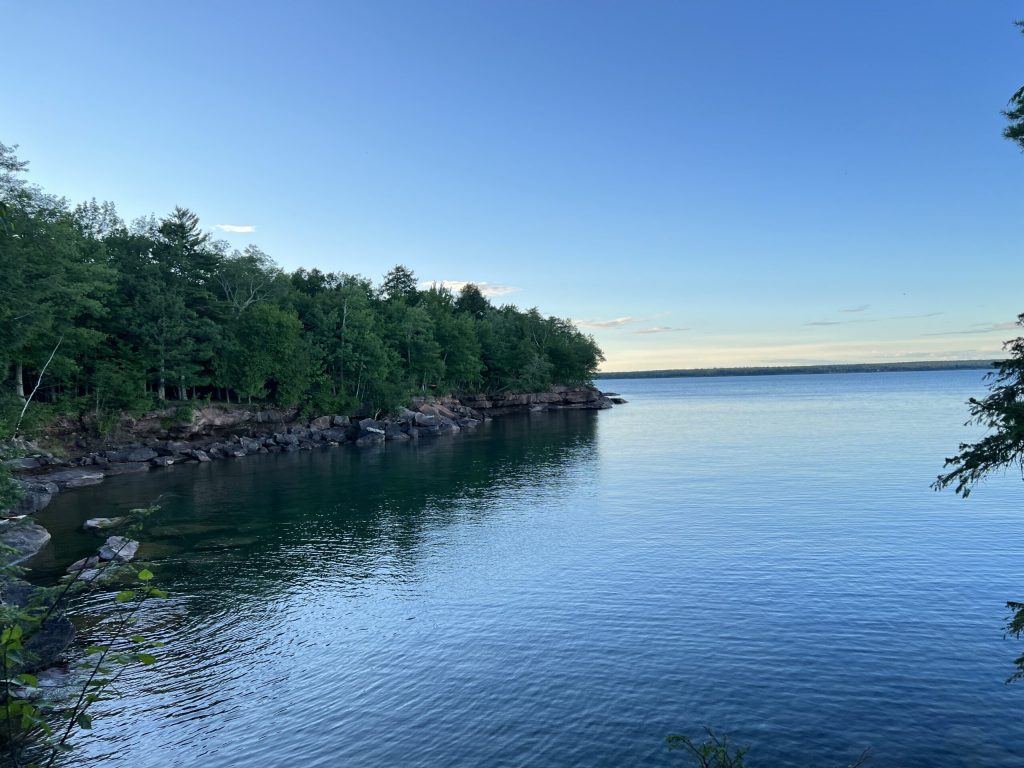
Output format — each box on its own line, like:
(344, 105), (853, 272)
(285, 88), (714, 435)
(0, 387), (625, 670)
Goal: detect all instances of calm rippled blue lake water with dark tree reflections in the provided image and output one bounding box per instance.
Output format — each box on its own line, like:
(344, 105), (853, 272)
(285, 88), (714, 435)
(29, 372), (1024, 768)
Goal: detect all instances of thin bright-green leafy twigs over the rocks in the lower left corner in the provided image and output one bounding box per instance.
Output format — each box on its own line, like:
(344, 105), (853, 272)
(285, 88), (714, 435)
(0, 508), (167, 768)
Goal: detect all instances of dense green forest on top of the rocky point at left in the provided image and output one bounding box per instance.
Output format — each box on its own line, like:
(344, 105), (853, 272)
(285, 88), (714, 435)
(0, 143), (603, 434)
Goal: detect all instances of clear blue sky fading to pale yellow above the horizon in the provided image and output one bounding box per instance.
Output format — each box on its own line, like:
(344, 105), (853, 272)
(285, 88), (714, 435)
(0, 0), (1024, 371)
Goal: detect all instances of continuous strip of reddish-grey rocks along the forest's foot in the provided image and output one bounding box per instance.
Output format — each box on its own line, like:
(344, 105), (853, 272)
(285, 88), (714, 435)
(5, 387), (625, 520)
